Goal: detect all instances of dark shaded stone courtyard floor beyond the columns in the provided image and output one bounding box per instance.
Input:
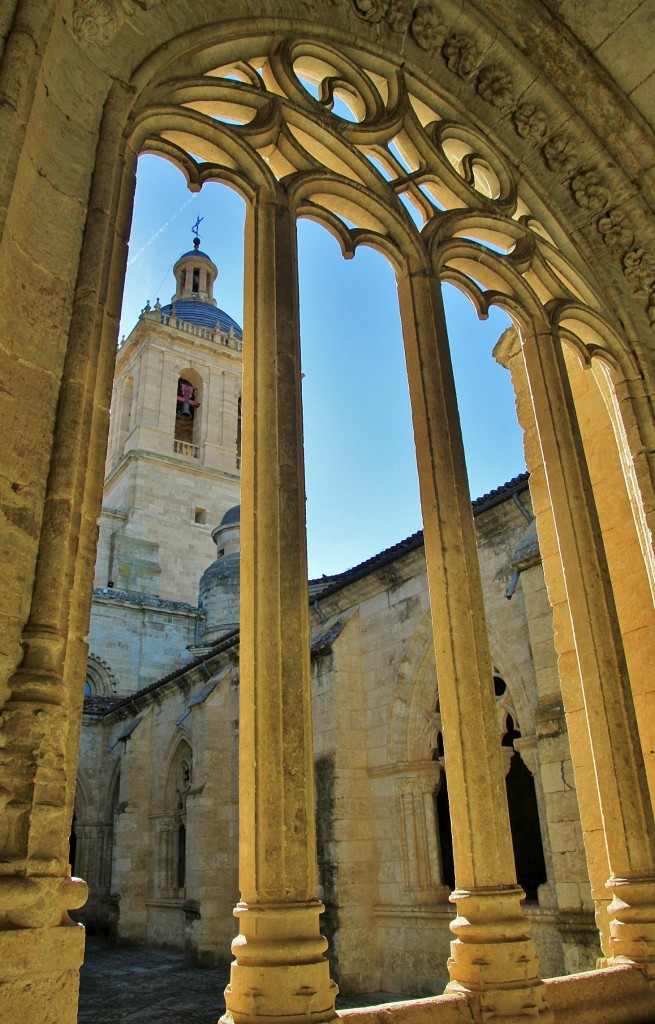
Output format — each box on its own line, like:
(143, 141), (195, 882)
(78, 938), (407, 1024)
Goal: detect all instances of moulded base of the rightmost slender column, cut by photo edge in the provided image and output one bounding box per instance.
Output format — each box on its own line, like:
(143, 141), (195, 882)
(598, 878), (655, 987)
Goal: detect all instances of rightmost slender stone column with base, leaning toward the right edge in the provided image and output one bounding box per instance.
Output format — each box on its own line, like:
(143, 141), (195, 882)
(522, 325), (655, 982)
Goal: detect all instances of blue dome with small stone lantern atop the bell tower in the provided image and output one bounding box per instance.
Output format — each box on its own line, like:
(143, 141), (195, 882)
(162, 237), (243, 341)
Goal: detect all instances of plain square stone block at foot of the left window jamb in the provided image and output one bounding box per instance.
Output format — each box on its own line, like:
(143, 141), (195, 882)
(0, 924), (84, 1024)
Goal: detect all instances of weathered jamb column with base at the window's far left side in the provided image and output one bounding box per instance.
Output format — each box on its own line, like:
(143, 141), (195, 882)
(0, 81), (136, 1024)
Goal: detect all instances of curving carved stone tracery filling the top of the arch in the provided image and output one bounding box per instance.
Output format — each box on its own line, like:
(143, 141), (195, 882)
(136, 34), (650, 380)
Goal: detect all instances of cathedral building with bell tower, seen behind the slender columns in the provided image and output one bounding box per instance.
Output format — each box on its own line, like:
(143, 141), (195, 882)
(74, 240), (600, 995)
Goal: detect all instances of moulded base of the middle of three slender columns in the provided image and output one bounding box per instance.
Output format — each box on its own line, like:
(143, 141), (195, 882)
(446, 886), (553, 1024)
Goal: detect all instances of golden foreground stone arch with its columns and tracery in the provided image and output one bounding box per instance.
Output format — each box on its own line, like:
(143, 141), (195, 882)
(0, 0), (655, 1024)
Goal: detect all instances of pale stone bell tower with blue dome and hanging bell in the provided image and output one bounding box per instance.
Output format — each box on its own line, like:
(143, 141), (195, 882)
(95, 237), (243, 604)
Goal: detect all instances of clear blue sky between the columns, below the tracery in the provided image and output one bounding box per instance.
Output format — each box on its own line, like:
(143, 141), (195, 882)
(121, 156), (525, 577)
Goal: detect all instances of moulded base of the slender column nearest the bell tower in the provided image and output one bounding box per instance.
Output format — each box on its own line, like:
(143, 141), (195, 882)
(222, 900), (339, 1024)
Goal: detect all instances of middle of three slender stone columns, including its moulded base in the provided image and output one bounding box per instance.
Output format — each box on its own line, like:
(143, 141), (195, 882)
(398, 267), (551, 1021)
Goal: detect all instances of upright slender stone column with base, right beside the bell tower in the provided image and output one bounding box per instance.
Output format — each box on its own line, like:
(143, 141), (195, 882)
(225, 197), (337, 1024)
